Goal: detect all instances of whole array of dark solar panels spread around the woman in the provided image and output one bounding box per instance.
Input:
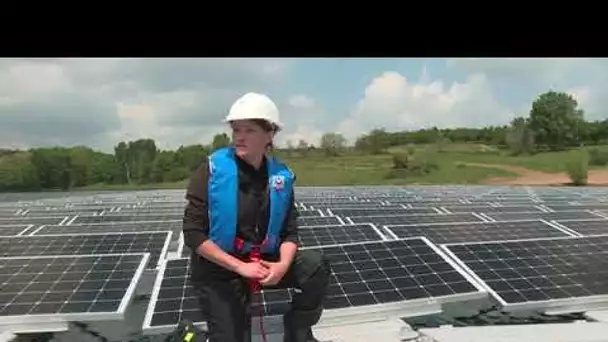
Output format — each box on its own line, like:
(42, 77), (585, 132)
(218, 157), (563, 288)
(0, 186), (608, 334)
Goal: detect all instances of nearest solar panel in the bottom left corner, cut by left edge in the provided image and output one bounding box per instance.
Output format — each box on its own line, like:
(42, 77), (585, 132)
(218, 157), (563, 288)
(0, 254), (149, 324)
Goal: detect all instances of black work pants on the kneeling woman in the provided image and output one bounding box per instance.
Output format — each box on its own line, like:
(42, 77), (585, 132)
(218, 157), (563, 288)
(192, 250), (330, 342)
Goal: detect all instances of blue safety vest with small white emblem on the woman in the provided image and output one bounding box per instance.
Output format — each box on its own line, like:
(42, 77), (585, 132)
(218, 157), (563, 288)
(207, 147), (296, 253)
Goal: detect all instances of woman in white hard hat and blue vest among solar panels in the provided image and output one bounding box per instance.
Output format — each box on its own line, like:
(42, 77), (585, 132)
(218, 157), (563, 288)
(183, 93), (330, 342)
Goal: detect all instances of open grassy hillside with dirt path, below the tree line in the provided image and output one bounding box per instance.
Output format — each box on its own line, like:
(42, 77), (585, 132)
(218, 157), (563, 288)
(34, 144), (608, 190)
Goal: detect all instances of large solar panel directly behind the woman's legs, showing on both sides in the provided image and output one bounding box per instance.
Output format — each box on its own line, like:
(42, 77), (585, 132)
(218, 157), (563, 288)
(144, 238), (486, 332)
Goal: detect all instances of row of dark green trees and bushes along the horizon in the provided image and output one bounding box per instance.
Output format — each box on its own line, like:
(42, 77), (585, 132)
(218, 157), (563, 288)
(0, 91), (608, 191)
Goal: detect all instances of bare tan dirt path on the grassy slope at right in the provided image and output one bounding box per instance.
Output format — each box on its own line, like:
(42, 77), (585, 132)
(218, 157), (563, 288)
(465, 163), (608, 185)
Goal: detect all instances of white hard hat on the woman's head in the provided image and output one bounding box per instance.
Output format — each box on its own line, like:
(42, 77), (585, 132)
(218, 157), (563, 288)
(224, 93), (282, 129)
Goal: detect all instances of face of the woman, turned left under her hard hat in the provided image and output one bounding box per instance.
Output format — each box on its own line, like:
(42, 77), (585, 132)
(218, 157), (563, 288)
(230, 120), (272, 158)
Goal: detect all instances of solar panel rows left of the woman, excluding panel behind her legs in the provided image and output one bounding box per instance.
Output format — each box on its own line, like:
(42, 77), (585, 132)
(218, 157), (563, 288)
(0, 190), (183, 332)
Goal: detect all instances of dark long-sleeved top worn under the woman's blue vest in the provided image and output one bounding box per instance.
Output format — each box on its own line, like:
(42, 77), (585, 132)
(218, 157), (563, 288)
(183, 158), (298, 278)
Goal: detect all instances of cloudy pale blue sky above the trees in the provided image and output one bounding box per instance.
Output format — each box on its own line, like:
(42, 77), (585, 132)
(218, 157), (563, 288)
(0, 58), (608, 152)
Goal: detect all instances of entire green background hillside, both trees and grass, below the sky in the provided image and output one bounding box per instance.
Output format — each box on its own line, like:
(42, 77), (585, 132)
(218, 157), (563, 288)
(0, 91), (608, 192)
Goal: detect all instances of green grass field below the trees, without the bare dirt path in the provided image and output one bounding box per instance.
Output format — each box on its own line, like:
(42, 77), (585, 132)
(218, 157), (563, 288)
(73, 144), (608, 190)
